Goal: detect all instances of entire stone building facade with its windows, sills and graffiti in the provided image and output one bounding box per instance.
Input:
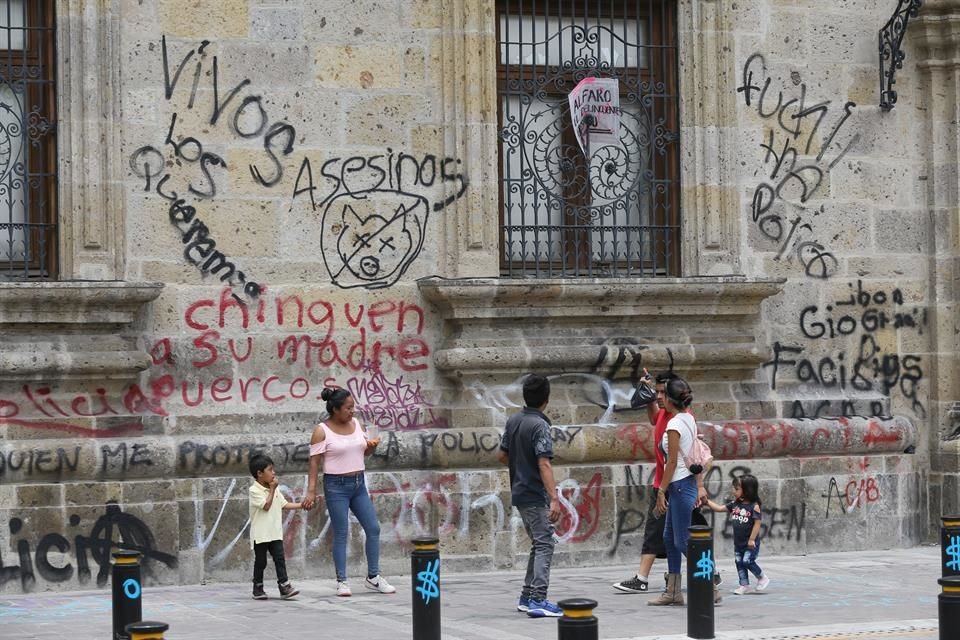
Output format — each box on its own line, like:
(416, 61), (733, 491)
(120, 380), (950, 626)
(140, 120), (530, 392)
(0, 0), (960, 593)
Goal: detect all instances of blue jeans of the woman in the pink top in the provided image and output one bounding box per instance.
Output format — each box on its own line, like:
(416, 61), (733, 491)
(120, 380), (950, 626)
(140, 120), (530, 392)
(323, 473), (380, 582)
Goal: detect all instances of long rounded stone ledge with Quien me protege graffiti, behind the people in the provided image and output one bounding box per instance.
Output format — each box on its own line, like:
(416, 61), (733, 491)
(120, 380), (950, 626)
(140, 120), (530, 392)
(0, 416), (918, 484)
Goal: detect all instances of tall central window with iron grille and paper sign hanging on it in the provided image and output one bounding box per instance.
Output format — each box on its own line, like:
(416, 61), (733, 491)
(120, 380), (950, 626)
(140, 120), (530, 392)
(497, 0), (680, 277)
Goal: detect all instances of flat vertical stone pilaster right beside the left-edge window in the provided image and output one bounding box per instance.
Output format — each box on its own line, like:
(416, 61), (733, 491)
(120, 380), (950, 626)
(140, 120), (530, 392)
(57, 0), (125, 280)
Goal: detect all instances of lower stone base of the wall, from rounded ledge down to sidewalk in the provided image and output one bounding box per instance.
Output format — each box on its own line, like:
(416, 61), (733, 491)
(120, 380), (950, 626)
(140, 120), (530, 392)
(0, 416), (923, 592)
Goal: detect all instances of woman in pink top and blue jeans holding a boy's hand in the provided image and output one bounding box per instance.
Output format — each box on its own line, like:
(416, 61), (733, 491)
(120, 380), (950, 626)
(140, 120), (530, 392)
(303, 388), (397, 596)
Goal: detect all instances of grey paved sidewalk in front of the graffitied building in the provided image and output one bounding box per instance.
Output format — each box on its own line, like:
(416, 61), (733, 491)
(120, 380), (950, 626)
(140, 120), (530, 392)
(0, 546), (944, 640)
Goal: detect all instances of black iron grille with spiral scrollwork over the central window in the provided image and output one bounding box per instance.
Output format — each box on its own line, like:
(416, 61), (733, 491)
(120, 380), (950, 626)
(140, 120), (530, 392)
(500, 13), (679, 277)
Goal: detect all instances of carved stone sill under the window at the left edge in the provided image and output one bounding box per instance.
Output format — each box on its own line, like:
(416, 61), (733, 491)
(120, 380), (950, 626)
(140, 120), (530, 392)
(0, 282), (163, 383)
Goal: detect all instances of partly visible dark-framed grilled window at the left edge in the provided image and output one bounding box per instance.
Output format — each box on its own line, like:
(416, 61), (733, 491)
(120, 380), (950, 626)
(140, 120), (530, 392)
(0, 0), (57, 280)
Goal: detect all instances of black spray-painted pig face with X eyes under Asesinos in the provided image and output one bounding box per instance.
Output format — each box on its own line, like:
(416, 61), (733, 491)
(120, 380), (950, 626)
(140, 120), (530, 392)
(322, 190), (429, 289)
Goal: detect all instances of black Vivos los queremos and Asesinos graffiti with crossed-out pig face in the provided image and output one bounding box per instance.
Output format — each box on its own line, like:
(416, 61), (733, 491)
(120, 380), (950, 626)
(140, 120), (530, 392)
(129, 36), (469, 302)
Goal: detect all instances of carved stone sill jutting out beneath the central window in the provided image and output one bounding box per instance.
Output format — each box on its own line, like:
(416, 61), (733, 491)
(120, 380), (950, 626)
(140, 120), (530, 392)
(418, 277), (783, 385)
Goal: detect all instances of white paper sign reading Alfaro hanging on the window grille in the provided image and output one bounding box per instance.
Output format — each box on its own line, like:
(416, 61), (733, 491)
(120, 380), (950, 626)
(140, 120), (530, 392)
(569, 78), (622, 156)
